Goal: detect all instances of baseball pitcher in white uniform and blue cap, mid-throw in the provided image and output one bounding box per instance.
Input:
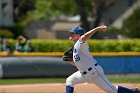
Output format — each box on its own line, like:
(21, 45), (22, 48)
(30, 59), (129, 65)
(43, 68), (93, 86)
(63, 25), (139, 93)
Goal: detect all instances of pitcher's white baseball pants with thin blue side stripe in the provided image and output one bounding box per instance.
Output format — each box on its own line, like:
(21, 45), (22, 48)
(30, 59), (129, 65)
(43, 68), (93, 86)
(66, 65), (118, 93)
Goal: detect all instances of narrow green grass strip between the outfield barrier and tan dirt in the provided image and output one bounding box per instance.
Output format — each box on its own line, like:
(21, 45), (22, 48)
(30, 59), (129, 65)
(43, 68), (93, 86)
(0, 75), (140, 85)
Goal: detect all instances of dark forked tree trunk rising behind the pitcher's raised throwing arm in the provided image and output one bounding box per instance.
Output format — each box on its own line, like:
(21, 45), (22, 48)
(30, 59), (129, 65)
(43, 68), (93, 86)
(91, 0), (116, 39)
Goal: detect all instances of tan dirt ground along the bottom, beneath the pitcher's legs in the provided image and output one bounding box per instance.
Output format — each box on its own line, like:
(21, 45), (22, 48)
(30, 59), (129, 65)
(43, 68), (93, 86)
(0, 83), (140, 93)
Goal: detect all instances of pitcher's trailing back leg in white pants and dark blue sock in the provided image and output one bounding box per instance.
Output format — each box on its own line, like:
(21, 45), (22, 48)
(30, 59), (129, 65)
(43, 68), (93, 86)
(89, 66), (136, 93)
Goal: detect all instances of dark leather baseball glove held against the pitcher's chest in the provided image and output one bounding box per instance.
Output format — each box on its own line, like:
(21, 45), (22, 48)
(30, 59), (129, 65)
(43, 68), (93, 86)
(63, 46), (73, 61)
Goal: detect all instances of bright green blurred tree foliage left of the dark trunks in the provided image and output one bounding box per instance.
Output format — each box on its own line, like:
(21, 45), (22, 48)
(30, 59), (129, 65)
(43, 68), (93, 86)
(16, 0), (77, 27)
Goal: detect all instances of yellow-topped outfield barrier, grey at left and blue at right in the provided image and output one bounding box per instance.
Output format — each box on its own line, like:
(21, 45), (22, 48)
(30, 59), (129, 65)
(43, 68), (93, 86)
(0, 52), (140, 78)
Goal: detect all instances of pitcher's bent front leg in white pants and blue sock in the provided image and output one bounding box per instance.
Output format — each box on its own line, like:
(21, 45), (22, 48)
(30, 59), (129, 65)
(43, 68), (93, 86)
(66, 71), (85, 93)
